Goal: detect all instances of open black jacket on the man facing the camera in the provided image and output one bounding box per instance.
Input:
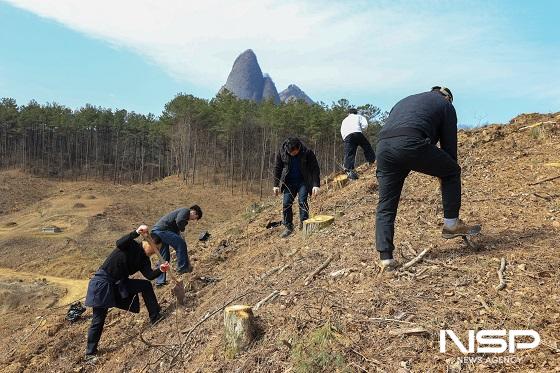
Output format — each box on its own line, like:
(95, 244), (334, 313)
(274, 139), (321, 192)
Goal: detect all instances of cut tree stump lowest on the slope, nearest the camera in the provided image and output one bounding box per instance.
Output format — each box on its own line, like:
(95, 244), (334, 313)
(224, 305), (255, 357)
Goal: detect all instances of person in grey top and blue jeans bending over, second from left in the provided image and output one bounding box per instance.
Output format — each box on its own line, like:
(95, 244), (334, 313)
(152, 205), (202, 286)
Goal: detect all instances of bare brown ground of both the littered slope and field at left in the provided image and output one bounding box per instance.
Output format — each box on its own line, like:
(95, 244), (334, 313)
(0, 114), (560, 372)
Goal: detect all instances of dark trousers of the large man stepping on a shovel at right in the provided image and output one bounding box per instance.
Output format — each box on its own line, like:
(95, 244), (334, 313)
(375, 136), (461, 259)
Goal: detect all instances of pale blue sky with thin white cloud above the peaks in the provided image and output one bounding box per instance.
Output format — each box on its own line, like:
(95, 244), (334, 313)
(0, 0), (560, 124)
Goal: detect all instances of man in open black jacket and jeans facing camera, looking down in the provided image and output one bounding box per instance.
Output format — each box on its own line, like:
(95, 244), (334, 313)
(272, 137), (321, 237)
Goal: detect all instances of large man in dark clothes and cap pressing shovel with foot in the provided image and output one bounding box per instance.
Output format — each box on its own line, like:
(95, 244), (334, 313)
(375, 86), (481, 270)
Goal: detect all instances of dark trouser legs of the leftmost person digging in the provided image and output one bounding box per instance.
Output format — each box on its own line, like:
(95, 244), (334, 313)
(86, 279), (160, 354)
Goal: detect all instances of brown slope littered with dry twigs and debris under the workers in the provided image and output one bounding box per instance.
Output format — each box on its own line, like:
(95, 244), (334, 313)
(3, 115), (560, 372)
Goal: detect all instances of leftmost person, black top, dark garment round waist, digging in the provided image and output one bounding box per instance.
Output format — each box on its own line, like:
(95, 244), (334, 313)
(85, 225), (169, 360)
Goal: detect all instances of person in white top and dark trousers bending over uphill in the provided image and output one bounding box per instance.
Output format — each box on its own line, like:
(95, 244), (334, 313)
(340, 108), (375, 180)
